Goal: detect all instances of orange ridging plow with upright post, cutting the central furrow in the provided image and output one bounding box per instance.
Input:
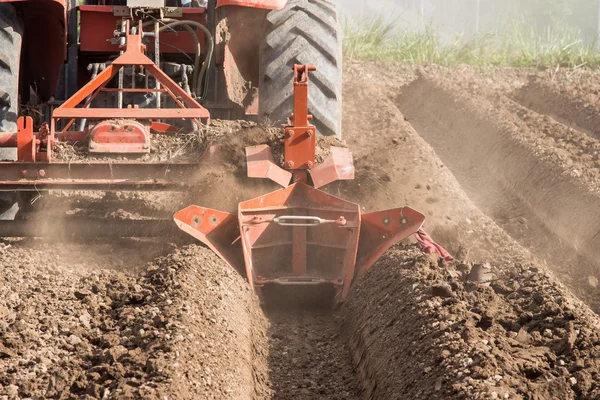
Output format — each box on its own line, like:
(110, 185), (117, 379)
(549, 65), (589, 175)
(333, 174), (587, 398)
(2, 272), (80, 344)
(174, 65), (425, 302)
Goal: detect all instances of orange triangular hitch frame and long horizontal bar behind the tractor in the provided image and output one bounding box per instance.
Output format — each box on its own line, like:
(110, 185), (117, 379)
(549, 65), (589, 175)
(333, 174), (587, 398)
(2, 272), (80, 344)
(0, 21), (210, 191)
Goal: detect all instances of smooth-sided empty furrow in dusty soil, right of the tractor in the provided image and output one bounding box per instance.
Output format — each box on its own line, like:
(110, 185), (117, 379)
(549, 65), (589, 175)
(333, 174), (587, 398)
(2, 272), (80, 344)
(398, 65), (600, 310)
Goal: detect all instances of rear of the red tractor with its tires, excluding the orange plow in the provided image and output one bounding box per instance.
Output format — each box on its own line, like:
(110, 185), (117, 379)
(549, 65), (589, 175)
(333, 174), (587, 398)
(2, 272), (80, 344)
(0, 0), (342, 220)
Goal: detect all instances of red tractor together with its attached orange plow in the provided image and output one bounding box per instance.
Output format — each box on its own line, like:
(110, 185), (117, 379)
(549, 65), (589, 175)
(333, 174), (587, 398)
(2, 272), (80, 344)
(0, 0), (443, 303)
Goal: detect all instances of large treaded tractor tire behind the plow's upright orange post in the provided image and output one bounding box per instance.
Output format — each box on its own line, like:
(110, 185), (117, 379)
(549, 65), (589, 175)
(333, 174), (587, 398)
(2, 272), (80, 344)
(259, 0), (342, 139)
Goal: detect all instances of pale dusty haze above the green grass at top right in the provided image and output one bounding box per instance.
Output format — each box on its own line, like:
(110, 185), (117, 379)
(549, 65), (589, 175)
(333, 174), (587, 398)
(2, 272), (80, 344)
(341, 0), (600, 42)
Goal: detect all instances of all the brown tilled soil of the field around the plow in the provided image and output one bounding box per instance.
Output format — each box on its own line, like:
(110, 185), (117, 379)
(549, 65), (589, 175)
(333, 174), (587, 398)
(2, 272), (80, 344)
(0, 63), (600, 399)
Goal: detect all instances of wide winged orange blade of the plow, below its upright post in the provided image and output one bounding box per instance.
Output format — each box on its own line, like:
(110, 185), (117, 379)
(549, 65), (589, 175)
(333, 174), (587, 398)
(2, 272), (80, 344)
(174, 195), (425, 302)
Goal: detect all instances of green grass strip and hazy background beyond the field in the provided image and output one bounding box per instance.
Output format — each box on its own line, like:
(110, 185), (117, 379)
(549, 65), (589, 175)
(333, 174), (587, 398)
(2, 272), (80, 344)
(344, 0), (600, 67)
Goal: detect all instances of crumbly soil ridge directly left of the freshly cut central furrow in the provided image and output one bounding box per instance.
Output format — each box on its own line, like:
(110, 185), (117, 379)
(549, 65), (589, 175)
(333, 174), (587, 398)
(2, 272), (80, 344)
(0, 242), (265, 399)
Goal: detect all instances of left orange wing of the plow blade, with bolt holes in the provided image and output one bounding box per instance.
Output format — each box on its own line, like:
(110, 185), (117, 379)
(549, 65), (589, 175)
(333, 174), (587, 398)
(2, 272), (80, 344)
(173, 206), (244, 273)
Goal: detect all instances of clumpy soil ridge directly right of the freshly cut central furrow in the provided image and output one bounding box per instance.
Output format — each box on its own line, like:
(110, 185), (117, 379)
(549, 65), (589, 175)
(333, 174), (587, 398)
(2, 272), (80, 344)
(342, 247), (600, 399)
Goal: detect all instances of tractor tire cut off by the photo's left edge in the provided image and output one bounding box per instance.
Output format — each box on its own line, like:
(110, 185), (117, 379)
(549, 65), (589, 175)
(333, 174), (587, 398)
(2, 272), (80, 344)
(0, 3), (23, 220)
